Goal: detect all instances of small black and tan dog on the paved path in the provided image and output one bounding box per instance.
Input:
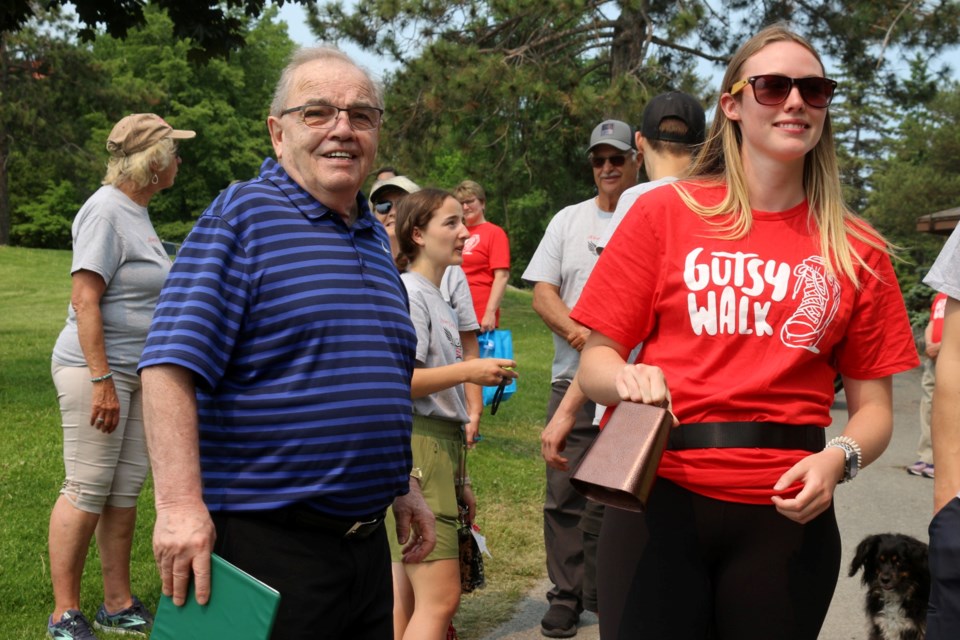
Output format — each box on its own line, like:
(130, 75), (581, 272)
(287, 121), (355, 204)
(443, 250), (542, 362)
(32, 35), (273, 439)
(850, 533), (930, 640)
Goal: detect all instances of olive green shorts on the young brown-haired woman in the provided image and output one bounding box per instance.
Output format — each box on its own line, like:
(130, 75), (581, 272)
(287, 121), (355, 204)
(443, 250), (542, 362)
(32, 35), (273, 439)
(387, 415), (464, 562)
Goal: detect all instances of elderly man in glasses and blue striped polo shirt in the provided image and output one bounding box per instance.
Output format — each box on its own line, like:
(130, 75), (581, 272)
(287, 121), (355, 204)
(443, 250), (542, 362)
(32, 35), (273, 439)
(140, 48), (435, 640)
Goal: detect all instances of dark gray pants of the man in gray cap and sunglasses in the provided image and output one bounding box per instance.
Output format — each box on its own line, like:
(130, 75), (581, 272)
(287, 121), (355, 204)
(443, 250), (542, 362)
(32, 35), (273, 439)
(543, 382), (599, 613)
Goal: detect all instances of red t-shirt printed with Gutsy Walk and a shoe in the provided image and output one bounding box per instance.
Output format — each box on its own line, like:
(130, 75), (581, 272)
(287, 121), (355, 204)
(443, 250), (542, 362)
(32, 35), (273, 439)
(571, 183), (918, 504)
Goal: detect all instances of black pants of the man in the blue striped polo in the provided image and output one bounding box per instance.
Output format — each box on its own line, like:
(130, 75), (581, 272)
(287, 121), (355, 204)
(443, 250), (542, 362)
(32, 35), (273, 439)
(212, 512), (393, 640)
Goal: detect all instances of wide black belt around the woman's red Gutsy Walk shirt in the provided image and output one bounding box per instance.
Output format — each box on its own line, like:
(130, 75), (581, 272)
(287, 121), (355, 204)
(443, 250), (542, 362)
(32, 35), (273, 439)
(667, 422), (826, 452)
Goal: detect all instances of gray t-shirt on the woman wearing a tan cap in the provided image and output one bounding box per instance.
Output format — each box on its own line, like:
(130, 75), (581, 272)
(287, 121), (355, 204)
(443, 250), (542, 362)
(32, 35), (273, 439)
(53, 185), (170, 374)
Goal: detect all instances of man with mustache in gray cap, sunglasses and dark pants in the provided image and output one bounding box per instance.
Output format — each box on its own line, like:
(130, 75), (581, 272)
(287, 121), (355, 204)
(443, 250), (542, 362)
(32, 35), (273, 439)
(523, 120), (640, 638)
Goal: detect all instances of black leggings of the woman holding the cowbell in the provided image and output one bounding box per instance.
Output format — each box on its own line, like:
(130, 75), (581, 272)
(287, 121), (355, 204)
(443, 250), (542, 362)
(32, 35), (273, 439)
(598, 478), (840, 640)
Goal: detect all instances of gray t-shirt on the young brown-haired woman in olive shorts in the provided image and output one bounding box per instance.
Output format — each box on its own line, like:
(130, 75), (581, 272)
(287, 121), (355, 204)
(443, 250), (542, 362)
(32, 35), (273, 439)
(400, 271), (470, 425)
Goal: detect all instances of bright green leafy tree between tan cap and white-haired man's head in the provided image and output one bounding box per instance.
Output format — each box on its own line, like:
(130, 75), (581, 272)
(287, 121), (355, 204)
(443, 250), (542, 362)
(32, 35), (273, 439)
(93, 7), (293, 240)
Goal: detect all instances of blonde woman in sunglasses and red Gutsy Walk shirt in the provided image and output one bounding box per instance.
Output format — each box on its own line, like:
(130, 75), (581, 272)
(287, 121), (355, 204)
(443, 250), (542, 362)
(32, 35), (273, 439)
(571, 25), (918, 640)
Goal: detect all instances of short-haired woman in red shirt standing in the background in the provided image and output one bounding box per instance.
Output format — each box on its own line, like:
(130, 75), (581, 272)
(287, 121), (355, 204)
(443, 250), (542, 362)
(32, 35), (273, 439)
(453, 180), (510, 333)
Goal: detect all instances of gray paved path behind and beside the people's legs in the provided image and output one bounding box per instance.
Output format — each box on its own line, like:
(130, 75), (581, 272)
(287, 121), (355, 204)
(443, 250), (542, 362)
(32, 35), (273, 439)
(482, 368), (933, 640)
